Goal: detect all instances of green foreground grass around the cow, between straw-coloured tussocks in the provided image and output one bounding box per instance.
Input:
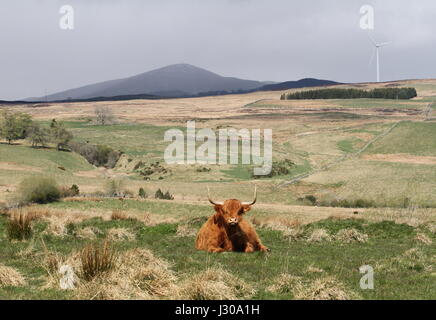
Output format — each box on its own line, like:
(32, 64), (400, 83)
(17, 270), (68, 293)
(0, 201), (436, 299)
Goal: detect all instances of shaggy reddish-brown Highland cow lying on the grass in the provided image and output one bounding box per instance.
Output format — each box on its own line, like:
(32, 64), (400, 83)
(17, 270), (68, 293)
(195, 188), (270, 252)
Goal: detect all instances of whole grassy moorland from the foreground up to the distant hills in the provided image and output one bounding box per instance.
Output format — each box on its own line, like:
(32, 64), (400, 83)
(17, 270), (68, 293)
(0, 80), (436, 299)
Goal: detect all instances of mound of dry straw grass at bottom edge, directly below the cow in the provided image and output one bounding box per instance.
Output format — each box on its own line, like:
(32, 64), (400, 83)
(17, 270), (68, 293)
(178, 267), (255, 300)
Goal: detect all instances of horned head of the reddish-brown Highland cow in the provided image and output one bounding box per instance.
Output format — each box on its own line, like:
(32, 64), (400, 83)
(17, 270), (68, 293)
(207, 187), (257, 227)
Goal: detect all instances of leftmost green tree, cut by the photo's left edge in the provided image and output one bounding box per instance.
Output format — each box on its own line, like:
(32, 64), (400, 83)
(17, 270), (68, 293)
(0, 110), (32, 144)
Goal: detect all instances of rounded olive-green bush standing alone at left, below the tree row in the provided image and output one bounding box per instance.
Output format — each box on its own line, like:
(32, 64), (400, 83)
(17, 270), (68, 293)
(18, 177), (61, 203)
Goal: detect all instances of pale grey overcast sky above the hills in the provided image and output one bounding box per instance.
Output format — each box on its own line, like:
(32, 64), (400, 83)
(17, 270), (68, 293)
(0, 0), (436, 99)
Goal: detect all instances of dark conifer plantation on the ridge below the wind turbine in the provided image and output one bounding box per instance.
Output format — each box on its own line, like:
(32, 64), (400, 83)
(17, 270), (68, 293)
(280, 88), (417, 100)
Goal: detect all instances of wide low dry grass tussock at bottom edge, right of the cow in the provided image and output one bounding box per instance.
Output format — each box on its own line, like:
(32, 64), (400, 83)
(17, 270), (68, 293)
(267, 273), (359, 300)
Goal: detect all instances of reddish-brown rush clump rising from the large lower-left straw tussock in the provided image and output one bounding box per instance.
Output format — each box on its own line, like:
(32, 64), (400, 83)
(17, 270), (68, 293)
(80, 241), (115, 281)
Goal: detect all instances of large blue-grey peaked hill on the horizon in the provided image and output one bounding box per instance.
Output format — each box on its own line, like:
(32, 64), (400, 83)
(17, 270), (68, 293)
(26, 64), (265, 101)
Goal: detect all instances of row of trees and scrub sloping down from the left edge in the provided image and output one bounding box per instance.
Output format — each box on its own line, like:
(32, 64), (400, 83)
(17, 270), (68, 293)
(0, 109), (122, 168)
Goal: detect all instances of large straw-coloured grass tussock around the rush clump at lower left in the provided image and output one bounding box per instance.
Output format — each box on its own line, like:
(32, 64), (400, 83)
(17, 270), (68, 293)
(45, 248), (178, 300)
